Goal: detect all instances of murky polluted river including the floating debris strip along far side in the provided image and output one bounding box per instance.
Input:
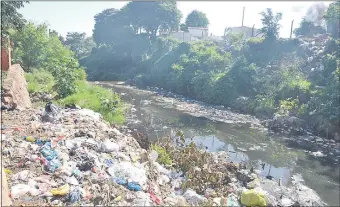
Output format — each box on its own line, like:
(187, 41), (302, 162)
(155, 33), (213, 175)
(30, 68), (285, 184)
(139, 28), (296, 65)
(100, 82), (340, 206)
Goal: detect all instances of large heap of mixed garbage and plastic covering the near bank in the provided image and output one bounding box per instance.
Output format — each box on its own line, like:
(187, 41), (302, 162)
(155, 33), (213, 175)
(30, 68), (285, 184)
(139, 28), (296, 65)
(1, 103), (322, 206)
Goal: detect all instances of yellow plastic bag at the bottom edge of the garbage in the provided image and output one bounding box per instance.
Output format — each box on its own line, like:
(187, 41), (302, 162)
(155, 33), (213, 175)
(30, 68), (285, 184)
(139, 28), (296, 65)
(241, 189), (267, 206)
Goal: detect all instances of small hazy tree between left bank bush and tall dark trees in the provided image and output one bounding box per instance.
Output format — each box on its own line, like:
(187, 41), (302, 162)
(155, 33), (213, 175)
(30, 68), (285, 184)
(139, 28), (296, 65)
(65, 32), (95, 58)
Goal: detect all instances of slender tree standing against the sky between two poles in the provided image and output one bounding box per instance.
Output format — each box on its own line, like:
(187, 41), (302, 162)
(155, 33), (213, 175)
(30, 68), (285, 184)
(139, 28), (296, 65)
(260, 8), (282, 40)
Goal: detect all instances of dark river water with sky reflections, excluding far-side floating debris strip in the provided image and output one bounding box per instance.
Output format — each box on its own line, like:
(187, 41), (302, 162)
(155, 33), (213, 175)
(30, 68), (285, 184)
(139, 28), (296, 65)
(100, 81), (340, 206)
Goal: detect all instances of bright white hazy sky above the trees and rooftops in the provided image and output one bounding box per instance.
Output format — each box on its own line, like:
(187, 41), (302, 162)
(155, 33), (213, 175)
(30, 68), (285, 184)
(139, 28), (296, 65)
(19, 1), (331, 37)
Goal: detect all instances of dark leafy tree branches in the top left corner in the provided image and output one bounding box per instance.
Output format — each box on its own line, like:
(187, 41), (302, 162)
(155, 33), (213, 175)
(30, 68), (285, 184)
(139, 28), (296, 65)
(1, 1), (29, 36)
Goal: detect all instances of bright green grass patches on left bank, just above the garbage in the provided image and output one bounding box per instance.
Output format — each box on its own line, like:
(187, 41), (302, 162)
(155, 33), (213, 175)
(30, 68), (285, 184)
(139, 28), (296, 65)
(25, 70), (125, 124)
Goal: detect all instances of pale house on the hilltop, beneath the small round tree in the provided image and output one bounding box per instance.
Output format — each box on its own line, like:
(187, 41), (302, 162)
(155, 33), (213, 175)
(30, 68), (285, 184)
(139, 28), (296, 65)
(159, 27), (209, 42)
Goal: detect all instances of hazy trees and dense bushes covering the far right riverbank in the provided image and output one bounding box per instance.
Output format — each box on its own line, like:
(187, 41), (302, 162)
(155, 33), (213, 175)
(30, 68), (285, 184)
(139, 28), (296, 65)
(73, 1), (340, 137)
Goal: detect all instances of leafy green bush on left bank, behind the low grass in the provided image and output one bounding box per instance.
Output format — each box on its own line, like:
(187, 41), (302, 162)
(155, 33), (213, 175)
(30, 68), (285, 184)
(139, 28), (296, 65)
(12, 23), (86, 97)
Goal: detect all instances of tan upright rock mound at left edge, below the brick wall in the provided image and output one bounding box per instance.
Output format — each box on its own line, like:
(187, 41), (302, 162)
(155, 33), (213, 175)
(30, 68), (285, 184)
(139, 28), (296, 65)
(1, 64), (32, 109)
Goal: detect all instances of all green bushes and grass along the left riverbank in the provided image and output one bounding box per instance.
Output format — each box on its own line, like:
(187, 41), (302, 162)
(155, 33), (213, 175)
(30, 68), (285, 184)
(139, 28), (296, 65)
(1, 3), (124, 124)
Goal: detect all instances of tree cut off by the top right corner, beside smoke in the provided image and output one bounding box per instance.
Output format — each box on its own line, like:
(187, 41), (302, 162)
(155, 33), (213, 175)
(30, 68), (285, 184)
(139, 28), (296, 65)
(324, 1), (340, 38)
